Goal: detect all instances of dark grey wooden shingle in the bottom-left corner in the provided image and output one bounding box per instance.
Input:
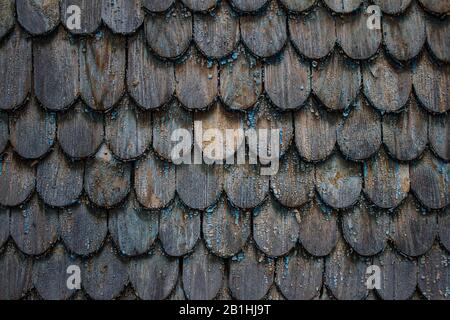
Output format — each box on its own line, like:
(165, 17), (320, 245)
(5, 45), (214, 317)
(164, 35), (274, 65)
(0, 244), (33, 300)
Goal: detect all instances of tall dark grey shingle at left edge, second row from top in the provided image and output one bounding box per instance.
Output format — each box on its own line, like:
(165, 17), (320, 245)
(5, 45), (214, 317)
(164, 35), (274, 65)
(0, 27), (33, 110)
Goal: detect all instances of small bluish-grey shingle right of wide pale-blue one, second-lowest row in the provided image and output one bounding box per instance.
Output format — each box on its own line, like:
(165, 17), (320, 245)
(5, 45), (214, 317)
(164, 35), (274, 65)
(159, 200), (201, 257)
